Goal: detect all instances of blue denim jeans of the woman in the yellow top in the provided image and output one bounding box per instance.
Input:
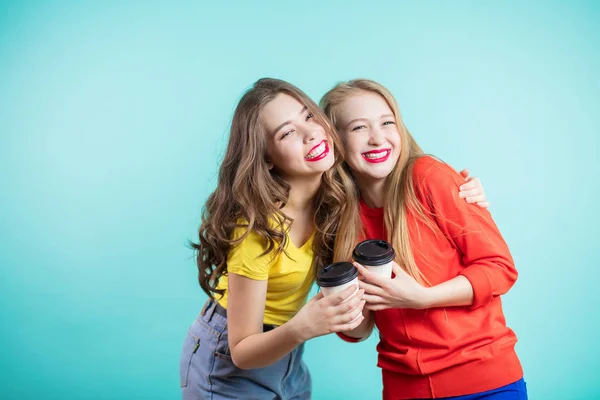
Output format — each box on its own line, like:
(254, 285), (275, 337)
(179, 300), (312, 400)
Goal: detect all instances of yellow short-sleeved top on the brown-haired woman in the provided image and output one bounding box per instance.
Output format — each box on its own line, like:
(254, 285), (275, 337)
(216, 228), (314, 325)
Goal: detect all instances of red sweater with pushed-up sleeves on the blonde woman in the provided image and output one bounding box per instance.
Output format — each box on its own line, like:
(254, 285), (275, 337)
(344, 157), (523, 400)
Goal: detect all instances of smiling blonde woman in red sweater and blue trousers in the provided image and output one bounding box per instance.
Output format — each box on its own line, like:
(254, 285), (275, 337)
(321, 79), (527, 400)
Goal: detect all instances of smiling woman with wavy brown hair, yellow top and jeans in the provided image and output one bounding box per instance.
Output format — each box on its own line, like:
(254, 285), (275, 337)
(180, 79), (364, 399)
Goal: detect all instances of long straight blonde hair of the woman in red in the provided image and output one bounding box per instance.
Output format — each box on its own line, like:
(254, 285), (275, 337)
(320, 79), (439, 284)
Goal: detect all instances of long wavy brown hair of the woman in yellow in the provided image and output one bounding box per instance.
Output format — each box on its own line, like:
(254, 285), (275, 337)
(192, 78), (345, 298)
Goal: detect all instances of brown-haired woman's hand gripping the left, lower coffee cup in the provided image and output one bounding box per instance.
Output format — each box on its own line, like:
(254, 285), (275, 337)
(290, 286), (365, 341)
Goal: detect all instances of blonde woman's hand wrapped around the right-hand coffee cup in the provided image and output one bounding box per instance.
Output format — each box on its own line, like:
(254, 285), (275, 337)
(354, 261), (428, 311)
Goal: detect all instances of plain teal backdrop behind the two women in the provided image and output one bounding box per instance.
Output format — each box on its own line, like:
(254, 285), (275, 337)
(0, 0), (600, 399)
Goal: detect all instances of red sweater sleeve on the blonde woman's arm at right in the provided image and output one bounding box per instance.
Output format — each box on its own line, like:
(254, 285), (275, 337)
(413, 157), (517, 308)
